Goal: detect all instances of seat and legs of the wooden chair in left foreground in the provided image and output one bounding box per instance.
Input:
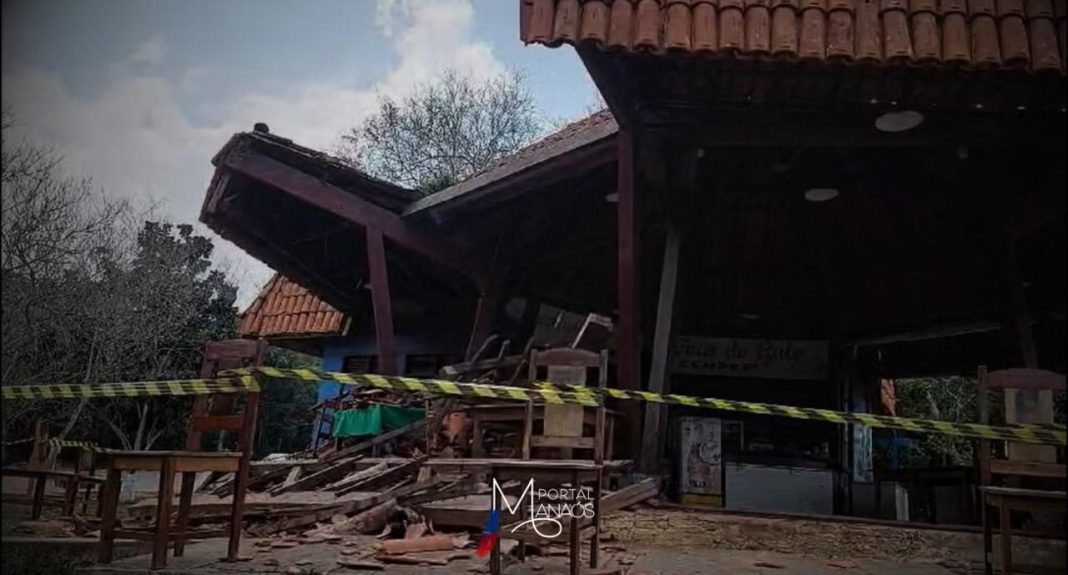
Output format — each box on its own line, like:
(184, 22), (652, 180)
(98, 451), (245, 569)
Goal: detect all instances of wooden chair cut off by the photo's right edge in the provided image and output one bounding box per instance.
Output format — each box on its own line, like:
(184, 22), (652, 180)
(978, 366), (1066, 575)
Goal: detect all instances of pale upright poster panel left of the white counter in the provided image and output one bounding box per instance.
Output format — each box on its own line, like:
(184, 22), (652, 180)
(678, 417), (723, 507)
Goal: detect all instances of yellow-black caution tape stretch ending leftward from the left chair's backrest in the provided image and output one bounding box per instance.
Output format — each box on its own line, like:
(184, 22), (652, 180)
(2, 375), (260, 400)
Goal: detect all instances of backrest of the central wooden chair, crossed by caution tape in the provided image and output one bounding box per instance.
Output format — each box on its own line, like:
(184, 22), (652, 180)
(522, 347), (612, 464)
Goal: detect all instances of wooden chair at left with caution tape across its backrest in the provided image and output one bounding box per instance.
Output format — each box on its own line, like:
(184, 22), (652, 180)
(98, 340), (267, 570)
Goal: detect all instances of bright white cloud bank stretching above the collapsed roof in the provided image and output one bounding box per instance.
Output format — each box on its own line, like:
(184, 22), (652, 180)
(3, 0), (505, 304)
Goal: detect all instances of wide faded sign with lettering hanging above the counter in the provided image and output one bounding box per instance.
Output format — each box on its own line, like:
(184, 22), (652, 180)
(671, 336), (828, 379)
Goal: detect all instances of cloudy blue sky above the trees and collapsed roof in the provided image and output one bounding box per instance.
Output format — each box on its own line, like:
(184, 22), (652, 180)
(2, 0), (595, 301)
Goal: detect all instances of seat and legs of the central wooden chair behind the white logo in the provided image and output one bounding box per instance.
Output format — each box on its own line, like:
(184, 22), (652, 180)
(442, 460), (604, 575)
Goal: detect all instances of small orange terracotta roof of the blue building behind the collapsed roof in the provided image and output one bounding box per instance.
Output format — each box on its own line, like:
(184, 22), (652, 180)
(237, 275), (346, 339)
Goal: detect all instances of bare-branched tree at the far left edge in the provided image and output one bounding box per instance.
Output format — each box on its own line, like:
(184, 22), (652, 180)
(0, 106), (129, 446)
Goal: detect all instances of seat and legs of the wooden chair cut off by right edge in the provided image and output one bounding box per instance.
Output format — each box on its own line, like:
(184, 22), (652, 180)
(979, 485), (1065, 575)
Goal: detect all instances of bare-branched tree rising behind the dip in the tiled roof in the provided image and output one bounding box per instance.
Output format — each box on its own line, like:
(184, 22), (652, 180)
(339, 71), (539, 195)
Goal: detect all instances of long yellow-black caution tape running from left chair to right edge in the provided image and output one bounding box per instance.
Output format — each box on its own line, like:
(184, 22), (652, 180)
(244, 368), (1065, 445)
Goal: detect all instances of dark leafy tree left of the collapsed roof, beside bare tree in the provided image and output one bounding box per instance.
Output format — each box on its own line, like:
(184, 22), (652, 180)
(83, 221), (237, 449)
